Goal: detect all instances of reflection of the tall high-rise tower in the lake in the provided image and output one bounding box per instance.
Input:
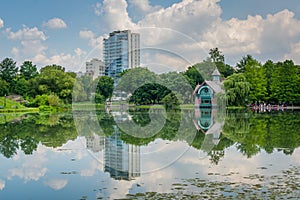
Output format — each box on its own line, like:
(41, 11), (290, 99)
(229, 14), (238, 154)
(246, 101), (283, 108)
(104, 126), (140, 180)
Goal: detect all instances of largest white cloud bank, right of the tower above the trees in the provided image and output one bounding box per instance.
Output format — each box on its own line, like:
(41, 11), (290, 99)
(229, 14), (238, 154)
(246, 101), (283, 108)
(135, 0), (300, 66)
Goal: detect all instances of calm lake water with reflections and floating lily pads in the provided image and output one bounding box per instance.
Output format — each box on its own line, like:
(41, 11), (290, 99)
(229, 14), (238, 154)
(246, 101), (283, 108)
(0, 109), (300, 200)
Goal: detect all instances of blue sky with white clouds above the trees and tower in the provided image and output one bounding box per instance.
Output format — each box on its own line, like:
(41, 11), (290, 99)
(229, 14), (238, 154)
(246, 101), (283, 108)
(0, 0), (300, 72)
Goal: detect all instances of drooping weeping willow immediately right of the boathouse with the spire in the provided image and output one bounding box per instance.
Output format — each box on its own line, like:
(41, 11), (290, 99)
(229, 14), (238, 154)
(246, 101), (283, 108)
(223, 74), (250, 106)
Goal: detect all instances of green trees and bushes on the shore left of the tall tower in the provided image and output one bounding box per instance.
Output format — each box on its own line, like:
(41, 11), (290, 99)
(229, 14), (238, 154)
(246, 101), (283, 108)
(0, 58), (114, 107)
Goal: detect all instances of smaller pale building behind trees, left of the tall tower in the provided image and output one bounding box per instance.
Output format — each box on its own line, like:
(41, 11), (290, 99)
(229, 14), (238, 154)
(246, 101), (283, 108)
(85, 58), (105, 79)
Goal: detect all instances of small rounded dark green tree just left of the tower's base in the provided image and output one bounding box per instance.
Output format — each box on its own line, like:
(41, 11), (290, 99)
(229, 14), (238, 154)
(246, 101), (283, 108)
(94, 76), (114, 99)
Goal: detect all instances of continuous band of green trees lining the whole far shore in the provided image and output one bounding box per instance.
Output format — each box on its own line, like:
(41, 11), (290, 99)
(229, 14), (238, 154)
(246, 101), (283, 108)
(0, 48), (300, 107)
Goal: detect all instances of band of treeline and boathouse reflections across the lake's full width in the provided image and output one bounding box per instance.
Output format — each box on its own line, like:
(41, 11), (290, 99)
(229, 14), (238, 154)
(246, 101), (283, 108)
(0, 109), (300, 161)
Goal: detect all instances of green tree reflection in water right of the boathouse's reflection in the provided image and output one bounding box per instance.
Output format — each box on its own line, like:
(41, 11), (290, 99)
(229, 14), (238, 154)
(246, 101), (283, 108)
(223, 111), (300, 157)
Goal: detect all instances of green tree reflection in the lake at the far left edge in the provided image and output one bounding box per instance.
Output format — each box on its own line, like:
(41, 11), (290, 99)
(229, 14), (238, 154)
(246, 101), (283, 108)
(0, 114), (77, 158)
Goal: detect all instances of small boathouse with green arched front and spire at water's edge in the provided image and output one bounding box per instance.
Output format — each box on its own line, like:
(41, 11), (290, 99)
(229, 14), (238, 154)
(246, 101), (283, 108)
(193, 68), (224, 108)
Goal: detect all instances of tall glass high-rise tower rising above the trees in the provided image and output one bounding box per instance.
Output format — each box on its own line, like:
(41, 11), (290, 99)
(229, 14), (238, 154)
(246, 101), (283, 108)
(103, 30), (140, 79)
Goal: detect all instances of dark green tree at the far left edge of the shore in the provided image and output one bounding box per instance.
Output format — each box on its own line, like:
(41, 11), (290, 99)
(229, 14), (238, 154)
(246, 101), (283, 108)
(0, 58), (18, 91)
